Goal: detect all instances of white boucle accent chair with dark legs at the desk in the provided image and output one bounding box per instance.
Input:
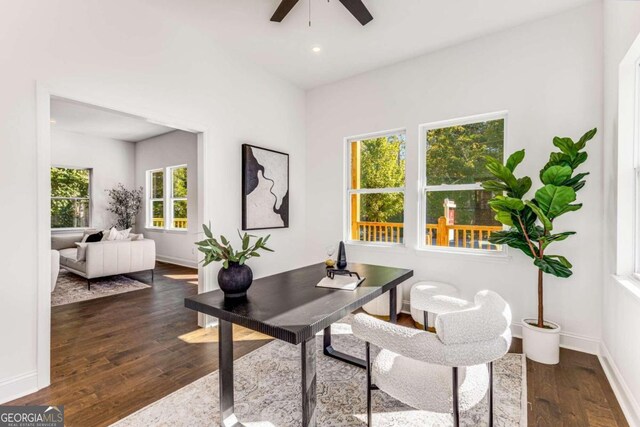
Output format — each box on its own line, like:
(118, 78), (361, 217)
(352, 291), (511, 427)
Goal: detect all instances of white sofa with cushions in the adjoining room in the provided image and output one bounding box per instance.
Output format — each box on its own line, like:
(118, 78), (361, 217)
(51, 234), (156, 289)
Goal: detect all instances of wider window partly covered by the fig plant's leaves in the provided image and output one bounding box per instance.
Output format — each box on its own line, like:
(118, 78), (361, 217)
(419, 113), (506, 252)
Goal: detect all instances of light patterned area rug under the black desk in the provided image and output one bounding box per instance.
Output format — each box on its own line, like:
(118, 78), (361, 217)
(113, 318), (527, 427)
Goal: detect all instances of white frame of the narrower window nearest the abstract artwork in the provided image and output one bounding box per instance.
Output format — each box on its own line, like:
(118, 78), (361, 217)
(343, 128), (407, 247)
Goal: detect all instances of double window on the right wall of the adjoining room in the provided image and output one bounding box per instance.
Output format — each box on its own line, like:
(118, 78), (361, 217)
(147, 165), (188, 230)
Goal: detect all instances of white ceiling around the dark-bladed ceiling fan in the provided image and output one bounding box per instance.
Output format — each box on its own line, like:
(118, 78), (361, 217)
(199, 0), (592, 89)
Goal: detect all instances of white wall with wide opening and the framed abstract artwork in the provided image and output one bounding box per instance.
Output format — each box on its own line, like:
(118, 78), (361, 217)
(0, 0), (307, 402)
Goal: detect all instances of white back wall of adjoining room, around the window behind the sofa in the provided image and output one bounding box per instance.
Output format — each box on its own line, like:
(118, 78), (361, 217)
(51, 126), (135, 229)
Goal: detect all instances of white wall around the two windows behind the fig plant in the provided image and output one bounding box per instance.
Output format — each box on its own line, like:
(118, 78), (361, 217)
(307, 3), (603, 351)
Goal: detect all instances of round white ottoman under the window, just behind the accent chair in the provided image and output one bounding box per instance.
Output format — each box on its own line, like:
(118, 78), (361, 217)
(409, 281), (466, 331)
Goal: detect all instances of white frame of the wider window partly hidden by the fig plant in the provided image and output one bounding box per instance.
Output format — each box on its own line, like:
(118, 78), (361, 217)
(416, 111), (508, 257)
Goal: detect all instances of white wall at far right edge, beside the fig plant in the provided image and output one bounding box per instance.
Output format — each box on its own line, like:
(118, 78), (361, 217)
(602, 0), (640, 425)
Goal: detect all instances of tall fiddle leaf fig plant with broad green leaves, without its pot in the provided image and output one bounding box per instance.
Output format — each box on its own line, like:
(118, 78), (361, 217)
(482, 128), (597, 328)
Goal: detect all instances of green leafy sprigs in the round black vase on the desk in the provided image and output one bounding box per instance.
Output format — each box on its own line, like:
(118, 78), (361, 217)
(196, 224), (273, 269)
